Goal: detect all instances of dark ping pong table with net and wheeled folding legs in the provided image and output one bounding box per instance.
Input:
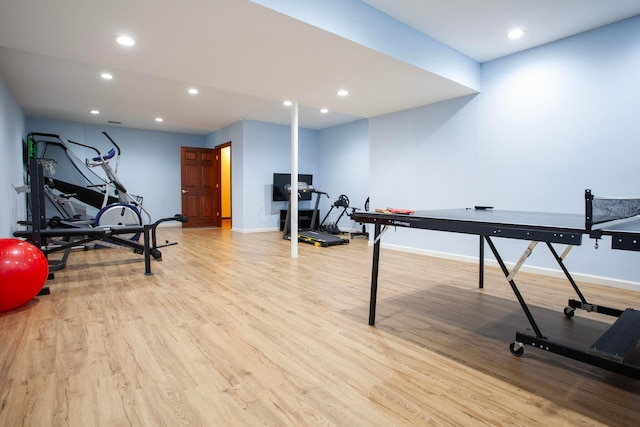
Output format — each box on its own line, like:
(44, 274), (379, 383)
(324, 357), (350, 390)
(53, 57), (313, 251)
(353, 190), (640, 379)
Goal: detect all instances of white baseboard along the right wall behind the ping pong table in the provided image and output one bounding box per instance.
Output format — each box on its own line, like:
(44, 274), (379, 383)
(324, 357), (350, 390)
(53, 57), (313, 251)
(378, 241), (640, 291)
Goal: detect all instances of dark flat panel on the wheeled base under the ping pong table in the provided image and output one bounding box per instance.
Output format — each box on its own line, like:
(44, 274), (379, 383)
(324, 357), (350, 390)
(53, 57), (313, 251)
(588, 308), (640, 363)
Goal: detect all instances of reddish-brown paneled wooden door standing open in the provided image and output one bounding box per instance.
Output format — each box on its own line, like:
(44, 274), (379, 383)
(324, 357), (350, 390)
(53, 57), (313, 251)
(180, 147), (222, 228)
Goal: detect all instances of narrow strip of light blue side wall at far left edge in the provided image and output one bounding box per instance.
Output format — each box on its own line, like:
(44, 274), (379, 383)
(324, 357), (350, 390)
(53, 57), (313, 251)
(0, 72), (26, 237)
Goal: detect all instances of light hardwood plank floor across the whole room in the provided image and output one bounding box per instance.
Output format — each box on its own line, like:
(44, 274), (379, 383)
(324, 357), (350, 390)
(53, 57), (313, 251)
(0, 227), (640, 427)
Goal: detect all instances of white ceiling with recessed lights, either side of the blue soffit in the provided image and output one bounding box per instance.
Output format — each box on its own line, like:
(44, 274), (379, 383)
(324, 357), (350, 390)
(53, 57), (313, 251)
(0, 0), (640, 134)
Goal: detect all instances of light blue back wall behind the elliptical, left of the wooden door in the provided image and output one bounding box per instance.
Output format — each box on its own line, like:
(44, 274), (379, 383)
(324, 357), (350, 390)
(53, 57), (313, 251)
(26, 118), (205, 221)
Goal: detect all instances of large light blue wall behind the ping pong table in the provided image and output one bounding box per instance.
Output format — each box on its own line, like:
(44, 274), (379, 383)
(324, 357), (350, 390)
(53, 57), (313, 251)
(370, 17), (640, 282)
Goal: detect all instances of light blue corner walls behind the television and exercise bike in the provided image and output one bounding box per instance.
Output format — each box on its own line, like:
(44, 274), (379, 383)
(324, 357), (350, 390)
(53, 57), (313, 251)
(206, 120), (369, 232)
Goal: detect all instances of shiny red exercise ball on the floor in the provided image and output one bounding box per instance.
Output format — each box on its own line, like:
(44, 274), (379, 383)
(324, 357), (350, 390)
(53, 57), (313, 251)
(0, 239), (49, 311)
